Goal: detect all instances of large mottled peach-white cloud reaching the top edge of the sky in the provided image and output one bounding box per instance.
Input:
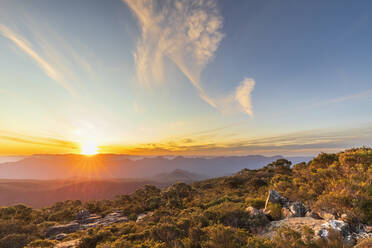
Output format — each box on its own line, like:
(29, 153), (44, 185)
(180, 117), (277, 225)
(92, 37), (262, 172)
(123, 0), (224, 107)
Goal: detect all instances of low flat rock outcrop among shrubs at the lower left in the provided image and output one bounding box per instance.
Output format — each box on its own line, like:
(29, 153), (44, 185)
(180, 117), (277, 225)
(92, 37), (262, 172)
(46, 210), (128, 239)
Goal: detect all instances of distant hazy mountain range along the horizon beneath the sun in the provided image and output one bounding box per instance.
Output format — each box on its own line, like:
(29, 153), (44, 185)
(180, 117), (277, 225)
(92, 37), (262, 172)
(0, 154), (309, 180)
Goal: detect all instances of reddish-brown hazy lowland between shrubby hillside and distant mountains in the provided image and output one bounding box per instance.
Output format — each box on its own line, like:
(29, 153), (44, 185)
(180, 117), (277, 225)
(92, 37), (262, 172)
(0, 179), (170, 208)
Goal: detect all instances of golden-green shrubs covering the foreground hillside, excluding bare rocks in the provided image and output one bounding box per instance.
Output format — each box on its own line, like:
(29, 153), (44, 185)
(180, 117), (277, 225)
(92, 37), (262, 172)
(0, 148), (372, 248)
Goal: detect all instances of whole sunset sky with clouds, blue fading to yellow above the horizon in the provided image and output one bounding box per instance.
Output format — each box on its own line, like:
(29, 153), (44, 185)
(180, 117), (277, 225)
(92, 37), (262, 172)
(0, 0), (372, 156)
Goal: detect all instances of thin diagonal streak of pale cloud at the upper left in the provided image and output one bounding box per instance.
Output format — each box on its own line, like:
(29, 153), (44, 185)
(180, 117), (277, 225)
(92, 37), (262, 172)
(0, 8), (97, 96)
